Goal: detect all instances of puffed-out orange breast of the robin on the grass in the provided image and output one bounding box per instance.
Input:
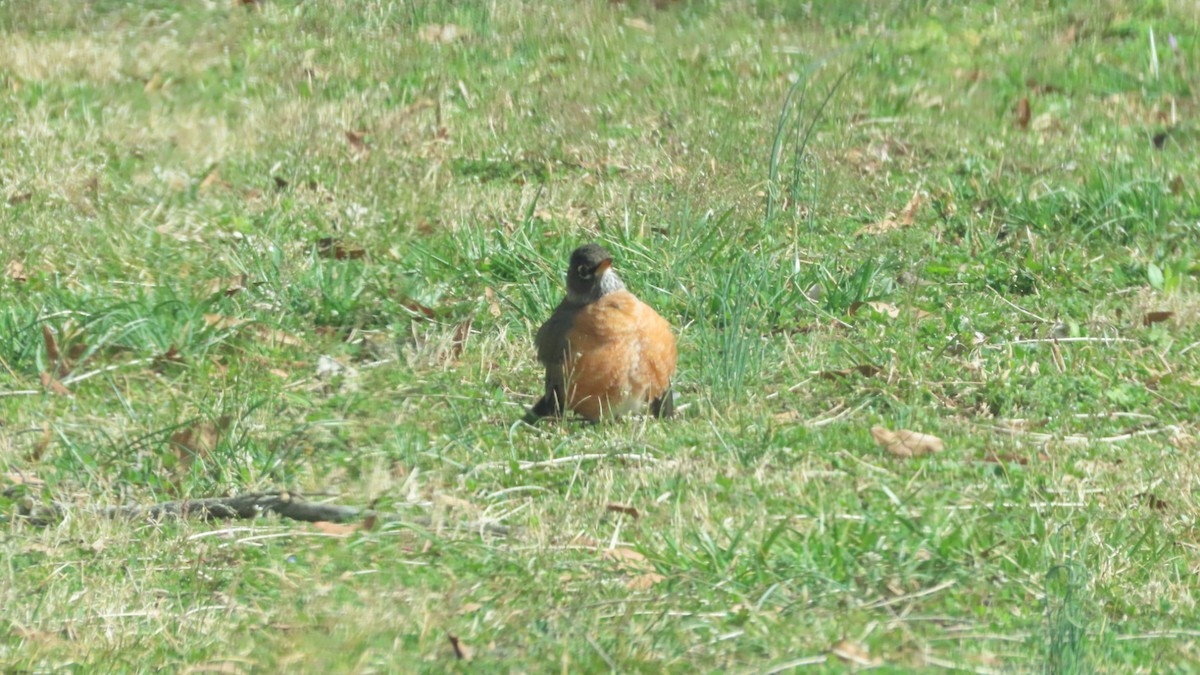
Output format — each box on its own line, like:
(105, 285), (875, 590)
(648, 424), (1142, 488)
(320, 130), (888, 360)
(564, 291), (677, 420)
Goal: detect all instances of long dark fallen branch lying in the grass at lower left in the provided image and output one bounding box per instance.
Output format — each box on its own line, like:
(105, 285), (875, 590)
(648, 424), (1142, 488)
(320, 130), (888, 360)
(15, 490), (509, 537)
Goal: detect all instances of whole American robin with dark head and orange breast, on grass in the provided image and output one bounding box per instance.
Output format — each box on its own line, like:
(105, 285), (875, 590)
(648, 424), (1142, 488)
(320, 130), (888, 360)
(526, 244), (676, 424)
